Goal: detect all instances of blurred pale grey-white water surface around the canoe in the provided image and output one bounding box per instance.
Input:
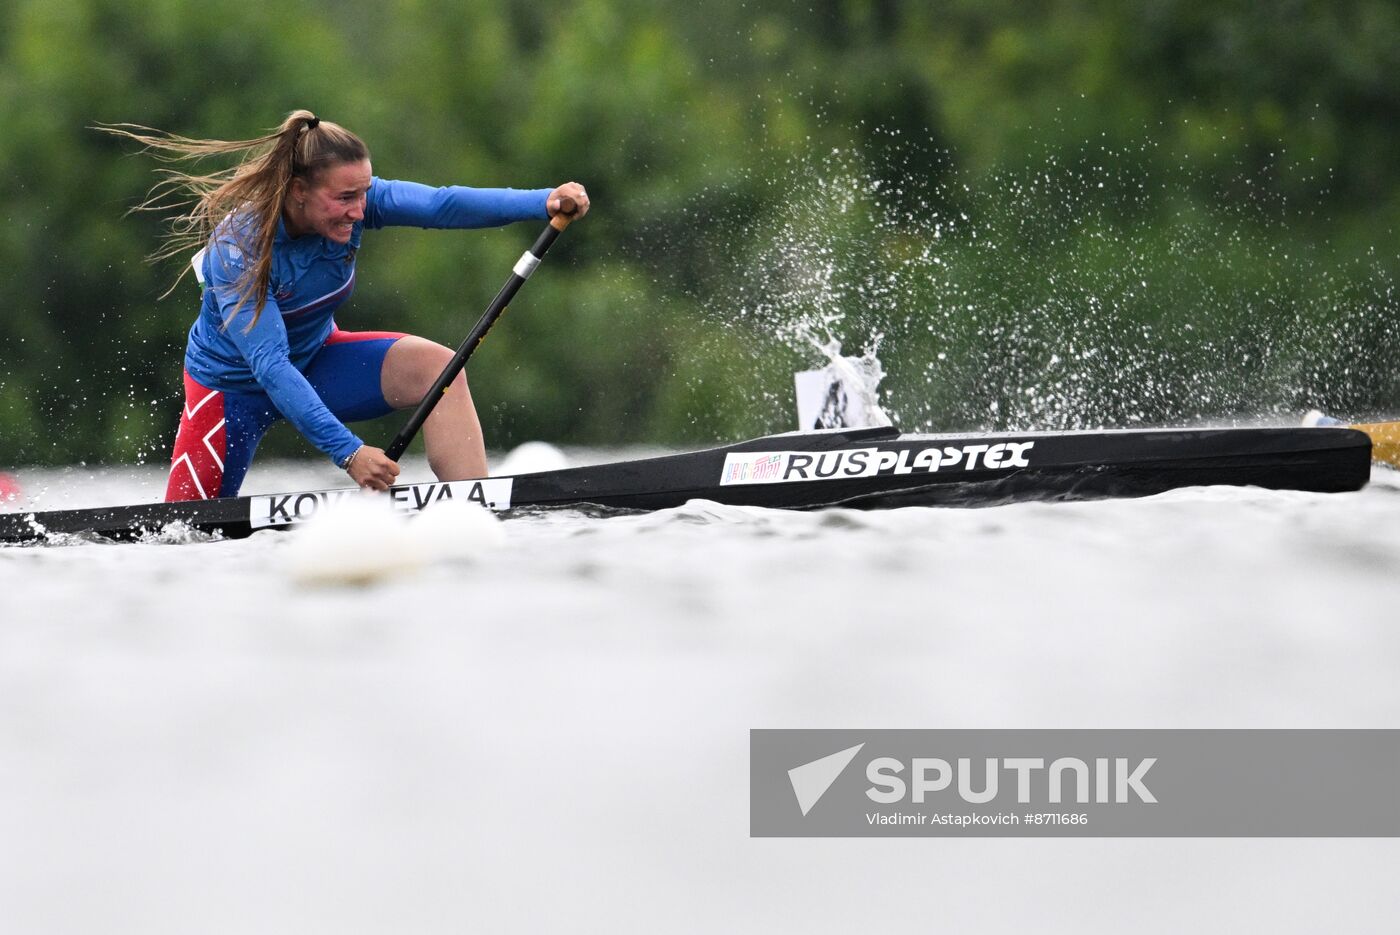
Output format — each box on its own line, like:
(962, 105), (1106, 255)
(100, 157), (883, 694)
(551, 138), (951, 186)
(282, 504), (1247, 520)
(0, 465), (1400, 935)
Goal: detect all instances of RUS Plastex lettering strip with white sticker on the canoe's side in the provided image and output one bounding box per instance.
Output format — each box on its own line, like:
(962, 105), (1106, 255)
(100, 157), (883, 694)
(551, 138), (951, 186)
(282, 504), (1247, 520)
(720, 441), (1036, 487)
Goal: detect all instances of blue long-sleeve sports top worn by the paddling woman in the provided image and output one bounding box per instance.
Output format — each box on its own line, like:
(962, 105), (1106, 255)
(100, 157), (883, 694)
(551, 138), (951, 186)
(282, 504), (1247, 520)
(185, 178), (550, 465)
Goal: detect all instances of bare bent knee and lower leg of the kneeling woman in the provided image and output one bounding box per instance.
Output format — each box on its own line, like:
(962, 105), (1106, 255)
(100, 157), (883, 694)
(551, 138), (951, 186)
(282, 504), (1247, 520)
(381, 335), (486, 480)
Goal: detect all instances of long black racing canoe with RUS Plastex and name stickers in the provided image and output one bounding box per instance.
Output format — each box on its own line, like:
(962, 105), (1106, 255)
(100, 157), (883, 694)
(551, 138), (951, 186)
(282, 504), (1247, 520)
(0, 428), (1371, 542)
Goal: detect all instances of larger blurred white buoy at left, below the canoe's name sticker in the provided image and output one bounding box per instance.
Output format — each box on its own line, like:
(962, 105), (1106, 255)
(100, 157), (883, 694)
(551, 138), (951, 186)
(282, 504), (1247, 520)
(287, 494), (431, 586)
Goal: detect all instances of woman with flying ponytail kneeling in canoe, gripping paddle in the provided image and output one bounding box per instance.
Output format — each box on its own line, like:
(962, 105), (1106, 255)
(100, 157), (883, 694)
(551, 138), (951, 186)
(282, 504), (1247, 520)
(106, 111), (588, 501)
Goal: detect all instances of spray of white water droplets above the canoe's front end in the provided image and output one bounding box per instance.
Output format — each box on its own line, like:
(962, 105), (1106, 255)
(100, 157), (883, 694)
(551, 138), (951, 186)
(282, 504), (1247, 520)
(666, 143), (1400, 430)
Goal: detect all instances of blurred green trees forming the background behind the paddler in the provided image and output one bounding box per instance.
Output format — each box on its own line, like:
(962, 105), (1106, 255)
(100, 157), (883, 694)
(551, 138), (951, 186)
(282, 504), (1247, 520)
(0, 0), (1400, 466)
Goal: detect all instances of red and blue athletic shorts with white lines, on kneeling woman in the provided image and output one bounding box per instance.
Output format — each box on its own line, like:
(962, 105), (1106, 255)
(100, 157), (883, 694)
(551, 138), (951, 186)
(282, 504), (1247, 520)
(165, 329), (403, 502)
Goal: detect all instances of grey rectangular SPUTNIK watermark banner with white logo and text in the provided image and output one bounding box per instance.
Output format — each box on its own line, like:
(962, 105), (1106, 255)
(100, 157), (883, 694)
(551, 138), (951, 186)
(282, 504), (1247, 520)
(750, 731), (1400, 837)
